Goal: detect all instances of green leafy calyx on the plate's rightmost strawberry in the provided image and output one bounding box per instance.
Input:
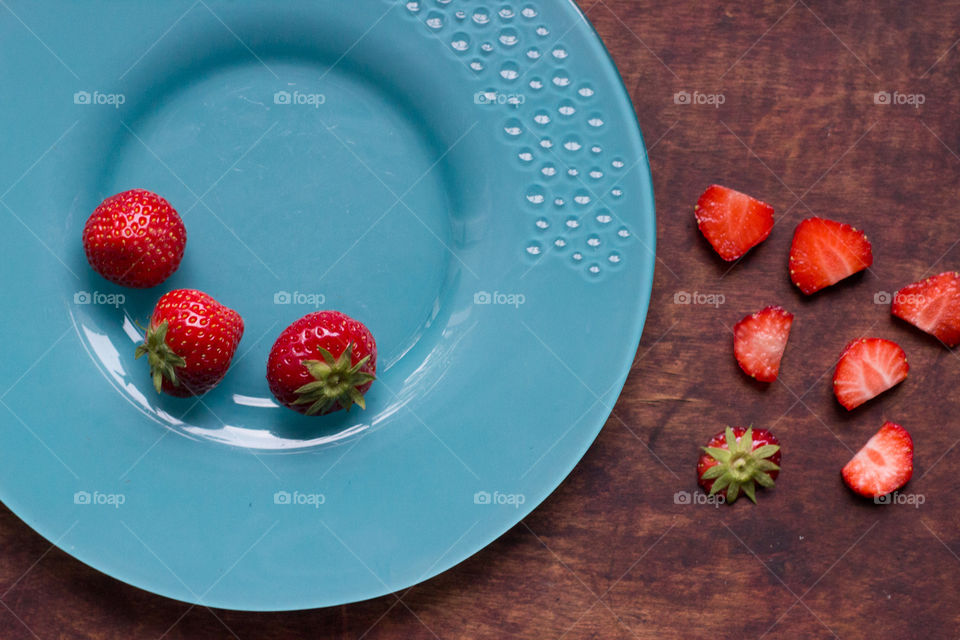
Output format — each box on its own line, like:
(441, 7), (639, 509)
(294, 342), (376, 416)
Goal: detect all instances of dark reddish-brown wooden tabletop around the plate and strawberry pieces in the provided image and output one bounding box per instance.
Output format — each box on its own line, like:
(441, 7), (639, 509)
(0, 0), (960, 640)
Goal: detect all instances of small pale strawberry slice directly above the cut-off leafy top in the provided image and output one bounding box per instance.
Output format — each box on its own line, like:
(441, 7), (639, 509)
(733, 306), (793, 382)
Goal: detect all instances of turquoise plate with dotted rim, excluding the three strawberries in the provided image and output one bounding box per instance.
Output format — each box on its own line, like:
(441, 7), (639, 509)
(0, 0), (654, 610)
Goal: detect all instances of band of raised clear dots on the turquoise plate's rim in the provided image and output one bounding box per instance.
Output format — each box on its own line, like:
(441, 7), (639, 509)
(402, 0), (632, 278)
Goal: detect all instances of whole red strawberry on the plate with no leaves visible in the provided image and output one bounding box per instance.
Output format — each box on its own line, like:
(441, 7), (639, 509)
(83, 189), (187, 289)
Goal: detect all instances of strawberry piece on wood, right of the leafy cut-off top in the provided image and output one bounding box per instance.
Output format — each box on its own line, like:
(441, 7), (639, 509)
(841, 422), (913, 498)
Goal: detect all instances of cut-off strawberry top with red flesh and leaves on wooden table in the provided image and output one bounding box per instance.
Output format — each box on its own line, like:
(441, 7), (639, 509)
(697, 427), (780, 502)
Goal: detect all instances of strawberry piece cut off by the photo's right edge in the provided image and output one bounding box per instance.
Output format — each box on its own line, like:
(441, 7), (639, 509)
(891, 271), (960, 347)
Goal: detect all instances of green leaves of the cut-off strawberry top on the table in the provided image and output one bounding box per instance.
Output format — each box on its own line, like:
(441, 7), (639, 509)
(700, 427), (780, 503)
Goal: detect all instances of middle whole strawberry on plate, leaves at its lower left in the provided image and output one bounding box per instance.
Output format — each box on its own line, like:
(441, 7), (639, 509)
(135, 289), (243, 398)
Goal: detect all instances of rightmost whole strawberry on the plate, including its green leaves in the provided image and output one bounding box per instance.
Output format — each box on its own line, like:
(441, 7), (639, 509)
(267, 311), (377, 416)
